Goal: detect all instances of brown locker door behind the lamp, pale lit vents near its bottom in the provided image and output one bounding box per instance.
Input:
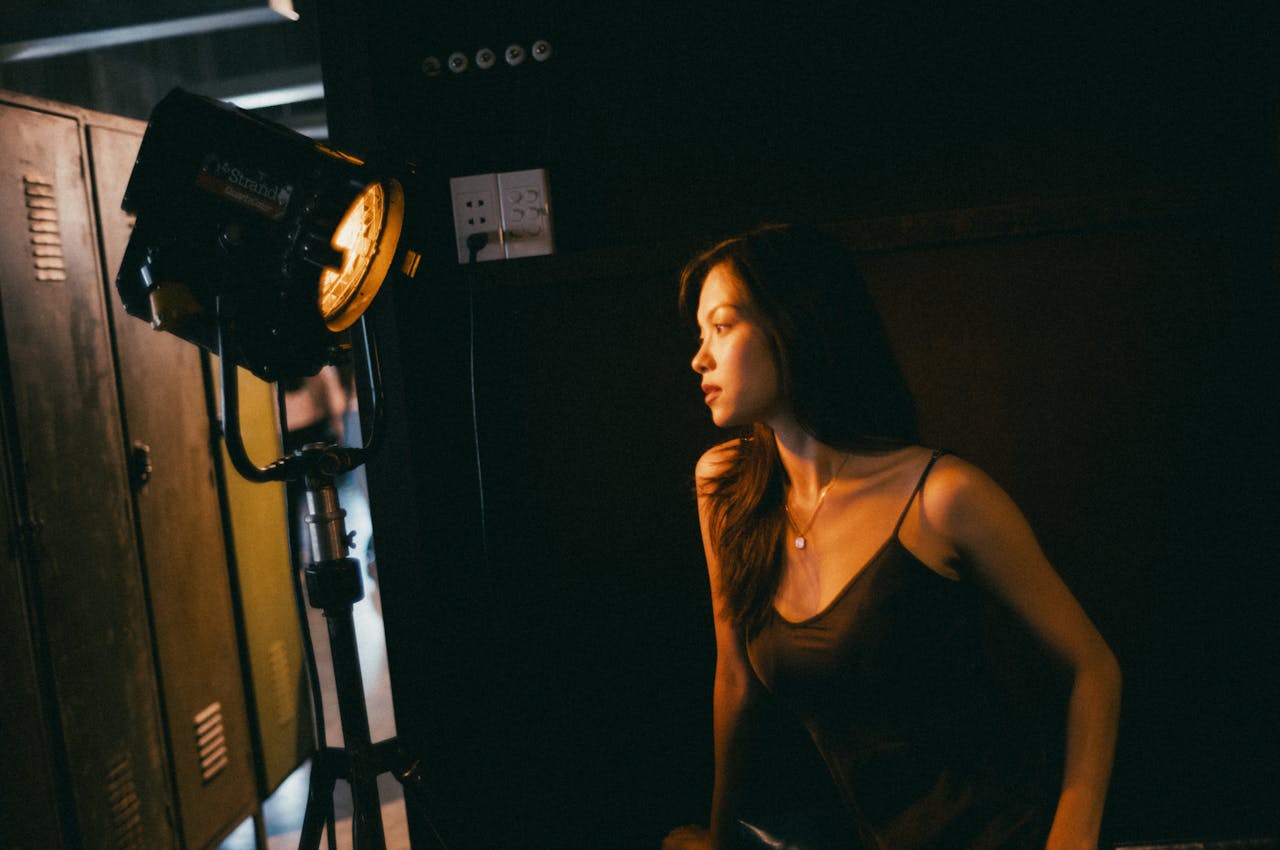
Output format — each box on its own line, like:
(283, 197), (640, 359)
(88, 122), (257, 849)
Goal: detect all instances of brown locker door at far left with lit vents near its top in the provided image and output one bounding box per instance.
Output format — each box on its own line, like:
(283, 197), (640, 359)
(0, 102), (174, 850)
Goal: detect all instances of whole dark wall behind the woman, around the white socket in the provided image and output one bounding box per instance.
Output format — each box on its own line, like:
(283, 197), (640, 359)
(312, 0), (1280, 847)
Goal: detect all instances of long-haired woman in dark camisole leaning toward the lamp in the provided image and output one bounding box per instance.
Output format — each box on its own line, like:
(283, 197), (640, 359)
(664, 227), (1120, 850)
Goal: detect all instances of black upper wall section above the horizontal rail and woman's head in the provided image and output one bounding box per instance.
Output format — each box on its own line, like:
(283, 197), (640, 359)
(348, 0), (1275, 250)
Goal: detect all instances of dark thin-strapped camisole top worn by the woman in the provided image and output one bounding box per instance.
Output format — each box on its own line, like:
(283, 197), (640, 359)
(748, 452), (1055, 850)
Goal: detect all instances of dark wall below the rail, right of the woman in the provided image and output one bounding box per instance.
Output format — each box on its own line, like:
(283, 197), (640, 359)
(864, 215), (1280, 838)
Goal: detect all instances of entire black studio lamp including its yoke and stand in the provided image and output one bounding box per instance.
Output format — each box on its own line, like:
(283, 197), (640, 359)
(115, 90), (421, 850)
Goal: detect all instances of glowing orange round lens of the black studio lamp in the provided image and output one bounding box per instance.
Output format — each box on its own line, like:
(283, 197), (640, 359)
(320, 180), (404, 332)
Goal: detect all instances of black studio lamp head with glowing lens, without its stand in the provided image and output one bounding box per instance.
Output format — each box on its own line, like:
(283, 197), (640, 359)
(116, 90), (419, 381)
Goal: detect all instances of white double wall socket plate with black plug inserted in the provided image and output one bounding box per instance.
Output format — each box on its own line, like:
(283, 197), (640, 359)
(449, 168), (554, 258)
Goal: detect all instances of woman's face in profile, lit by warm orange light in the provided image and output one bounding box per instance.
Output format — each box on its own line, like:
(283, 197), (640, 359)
(691, 262), (781, 428)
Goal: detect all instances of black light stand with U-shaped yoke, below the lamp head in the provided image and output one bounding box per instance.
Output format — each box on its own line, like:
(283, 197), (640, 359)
(218, 314), (445, 850)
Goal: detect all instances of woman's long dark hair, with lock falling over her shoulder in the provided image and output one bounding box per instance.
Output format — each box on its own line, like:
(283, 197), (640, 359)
(680, 225), (918, 632)
